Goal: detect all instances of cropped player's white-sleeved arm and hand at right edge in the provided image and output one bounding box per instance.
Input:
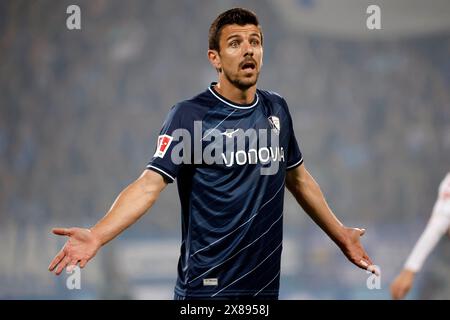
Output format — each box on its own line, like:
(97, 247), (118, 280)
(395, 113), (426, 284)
(391, 172), (450, 299)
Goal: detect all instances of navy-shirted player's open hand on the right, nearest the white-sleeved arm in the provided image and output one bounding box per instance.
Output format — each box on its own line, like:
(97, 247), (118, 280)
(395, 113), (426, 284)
(340, 228), (379, 276)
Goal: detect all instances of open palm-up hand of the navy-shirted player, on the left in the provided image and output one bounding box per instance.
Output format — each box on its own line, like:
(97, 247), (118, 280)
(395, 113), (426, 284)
(48, 228), (101, 275)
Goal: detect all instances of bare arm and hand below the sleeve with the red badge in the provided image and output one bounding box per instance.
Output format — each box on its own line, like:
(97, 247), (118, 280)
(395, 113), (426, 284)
(49, 170), (167, 275)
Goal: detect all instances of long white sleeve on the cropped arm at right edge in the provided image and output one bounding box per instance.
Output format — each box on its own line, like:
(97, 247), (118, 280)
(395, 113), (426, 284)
(405, 196), (450, 272)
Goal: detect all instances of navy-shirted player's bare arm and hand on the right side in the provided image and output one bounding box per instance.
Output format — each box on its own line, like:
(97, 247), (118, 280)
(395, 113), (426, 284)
(286, 164), (377, 273)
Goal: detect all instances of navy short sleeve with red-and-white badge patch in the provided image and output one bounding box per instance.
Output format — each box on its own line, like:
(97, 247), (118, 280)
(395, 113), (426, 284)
(146, 105), (187, 183)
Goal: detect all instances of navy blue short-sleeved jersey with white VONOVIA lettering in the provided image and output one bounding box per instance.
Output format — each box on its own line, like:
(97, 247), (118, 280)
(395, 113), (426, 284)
(147, 83), (303, 298)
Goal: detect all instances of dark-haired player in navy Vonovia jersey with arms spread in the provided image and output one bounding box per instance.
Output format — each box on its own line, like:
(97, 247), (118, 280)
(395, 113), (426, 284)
(49, 8), (375, 300)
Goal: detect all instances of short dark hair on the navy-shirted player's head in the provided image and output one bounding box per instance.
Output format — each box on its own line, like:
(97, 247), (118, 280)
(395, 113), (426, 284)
(208, 8), (262, 51)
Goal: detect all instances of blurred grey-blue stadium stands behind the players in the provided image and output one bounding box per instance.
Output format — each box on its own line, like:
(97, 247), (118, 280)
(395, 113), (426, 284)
(0, 0), (450, 299)
